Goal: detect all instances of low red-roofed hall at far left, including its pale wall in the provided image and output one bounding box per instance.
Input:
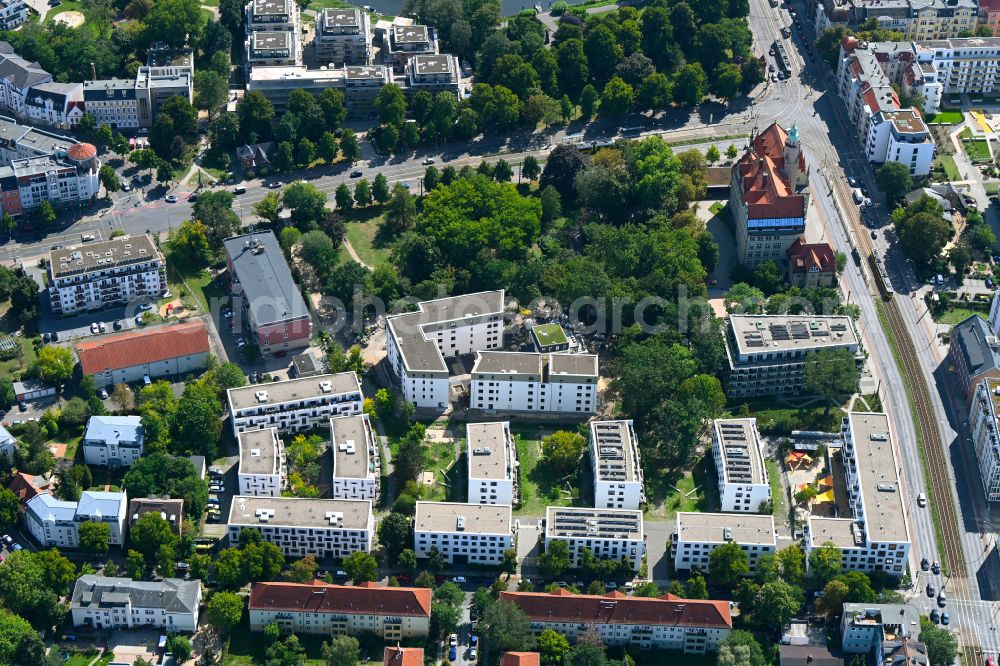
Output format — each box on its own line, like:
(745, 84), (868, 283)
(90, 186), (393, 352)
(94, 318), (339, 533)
(76, 321), (209, 388)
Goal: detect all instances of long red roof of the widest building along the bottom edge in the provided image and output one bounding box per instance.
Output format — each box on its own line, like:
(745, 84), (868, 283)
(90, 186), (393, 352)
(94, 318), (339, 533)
(500, 590), (733, 629)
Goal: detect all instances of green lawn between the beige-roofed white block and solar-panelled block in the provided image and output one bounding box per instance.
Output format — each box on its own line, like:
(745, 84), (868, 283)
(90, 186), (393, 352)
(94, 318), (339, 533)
(511, 426), (582, 516)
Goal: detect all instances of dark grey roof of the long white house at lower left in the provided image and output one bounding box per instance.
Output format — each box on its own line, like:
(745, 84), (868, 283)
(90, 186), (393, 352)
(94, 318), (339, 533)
(73, 574), (201, 613)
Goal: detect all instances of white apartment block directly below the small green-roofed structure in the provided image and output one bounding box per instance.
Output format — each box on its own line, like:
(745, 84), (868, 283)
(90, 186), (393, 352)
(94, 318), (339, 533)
(469, 351), (597, 416)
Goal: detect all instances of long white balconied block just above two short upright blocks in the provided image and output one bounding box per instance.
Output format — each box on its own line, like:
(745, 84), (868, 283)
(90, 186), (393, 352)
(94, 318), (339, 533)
(227, 372), (364, 434)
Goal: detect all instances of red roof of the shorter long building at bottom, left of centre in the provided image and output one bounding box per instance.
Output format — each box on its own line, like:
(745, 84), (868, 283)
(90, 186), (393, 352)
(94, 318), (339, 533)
(250, 580), (431, 618)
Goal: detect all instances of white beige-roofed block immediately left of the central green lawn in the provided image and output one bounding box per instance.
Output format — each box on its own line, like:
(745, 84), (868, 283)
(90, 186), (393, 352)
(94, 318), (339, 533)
(465, 421), (521, 505)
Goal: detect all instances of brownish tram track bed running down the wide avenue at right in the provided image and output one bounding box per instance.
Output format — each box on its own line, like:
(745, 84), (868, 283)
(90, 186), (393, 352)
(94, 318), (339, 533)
(832, 174), (985, 666)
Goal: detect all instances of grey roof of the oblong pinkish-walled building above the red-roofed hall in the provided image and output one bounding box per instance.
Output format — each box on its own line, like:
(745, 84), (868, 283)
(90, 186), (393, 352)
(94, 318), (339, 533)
(223, 231), (309, 326)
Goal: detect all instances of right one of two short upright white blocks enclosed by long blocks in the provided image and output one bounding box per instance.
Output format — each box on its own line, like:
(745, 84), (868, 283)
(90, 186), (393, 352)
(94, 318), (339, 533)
(330, 414), (382, 502)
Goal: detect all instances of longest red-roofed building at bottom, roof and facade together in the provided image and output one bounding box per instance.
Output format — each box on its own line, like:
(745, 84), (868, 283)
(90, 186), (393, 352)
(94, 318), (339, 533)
(500, 589), (733, 654)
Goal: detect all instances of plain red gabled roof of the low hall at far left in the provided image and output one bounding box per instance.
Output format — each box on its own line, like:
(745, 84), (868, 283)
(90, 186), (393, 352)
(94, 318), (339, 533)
(76, 321), (209, 375)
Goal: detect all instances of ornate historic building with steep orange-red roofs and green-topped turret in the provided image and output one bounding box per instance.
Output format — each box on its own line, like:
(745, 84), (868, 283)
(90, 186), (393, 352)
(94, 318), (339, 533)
(729, 123), (809, 268)
